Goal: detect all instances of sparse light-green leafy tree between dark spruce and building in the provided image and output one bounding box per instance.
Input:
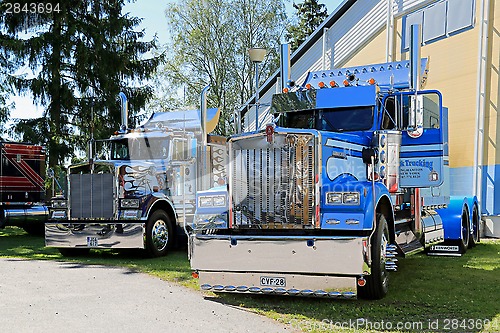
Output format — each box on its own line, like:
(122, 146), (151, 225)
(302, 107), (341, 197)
(152, 0), (286, 135)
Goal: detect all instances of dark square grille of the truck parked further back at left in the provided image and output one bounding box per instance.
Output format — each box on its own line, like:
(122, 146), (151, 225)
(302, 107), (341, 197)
(69, 173), (113, 219)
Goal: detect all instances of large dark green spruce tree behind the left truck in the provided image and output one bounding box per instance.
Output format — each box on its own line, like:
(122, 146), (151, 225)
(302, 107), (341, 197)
(0, 0), (161, 167)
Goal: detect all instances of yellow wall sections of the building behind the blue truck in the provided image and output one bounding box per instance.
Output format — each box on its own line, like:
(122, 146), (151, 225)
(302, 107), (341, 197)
(341, 0), (488, 168)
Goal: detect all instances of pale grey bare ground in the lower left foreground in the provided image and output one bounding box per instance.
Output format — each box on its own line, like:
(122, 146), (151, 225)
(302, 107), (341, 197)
(0, 258), (296, 333)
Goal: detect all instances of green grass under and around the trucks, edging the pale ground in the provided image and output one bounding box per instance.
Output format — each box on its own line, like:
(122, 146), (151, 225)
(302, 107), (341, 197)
(0, 228), (500, 332)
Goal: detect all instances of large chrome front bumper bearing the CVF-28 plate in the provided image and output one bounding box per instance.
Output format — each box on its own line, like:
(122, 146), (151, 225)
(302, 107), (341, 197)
(190, 235), (370, 298)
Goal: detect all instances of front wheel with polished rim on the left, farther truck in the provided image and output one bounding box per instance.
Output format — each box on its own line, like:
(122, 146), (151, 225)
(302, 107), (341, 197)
(146, 210), (174, 258)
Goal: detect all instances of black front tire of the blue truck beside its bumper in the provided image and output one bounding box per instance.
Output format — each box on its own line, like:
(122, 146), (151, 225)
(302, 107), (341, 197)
(358, 214), (390, 299)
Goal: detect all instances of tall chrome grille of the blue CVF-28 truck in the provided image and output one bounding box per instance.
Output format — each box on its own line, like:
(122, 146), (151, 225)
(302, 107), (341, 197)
(230, 133), (315, 229)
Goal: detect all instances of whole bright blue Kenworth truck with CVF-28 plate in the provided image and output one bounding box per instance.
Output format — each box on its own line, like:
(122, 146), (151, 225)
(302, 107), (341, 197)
(189, 46), (480, 299)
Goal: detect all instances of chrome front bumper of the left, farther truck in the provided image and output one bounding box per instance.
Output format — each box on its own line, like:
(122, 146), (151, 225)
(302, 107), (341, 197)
(45, 221), (146, 249)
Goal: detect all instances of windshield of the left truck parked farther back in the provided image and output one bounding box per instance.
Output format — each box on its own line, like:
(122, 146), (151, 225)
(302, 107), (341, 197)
(111, 137), (168, 160)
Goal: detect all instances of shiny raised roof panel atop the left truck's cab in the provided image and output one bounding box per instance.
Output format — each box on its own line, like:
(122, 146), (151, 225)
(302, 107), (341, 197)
(143, 108), (220, 133)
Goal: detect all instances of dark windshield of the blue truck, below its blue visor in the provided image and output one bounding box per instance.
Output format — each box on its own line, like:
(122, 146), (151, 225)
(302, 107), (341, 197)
(283, 106), (373, 132)
